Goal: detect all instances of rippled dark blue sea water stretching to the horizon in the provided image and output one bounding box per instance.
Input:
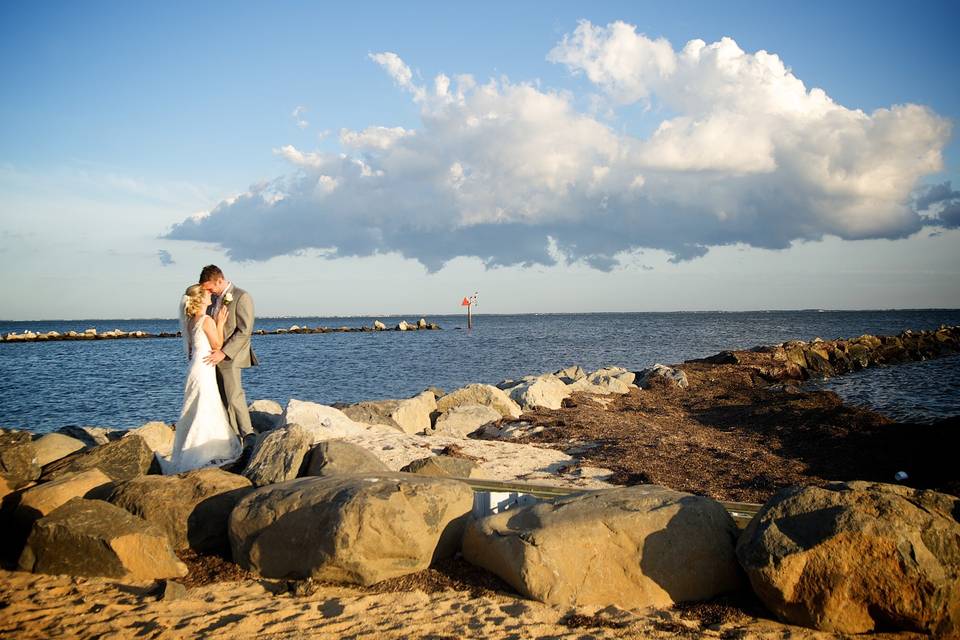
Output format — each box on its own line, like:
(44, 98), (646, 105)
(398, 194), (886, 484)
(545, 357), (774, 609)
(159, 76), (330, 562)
(0, 310), (960, 432)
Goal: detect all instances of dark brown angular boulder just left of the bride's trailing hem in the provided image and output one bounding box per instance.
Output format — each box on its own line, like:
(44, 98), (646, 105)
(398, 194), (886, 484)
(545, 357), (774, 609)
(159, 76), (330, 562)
(41, 435), (160, 482)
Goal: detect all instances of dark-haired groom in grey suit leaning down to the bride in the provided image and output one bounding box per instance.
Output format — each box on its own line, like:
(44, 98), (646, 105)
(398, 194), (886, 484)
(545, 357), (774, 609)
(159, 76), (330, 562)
(200, 264), (257, 440)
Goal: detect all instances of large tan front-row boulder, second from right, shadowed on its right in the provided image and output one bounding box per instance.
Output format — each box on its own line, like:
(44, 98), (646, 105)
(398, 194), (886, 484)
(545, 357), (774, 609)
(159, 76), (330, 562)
(463, 485), (741, 609)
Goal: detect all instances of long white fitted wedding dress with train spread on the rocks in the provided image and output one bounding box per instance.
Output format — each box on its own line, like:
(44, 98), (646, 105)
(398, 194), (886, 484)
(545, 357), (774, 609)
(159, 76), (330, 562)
(161, 322), (243, 475)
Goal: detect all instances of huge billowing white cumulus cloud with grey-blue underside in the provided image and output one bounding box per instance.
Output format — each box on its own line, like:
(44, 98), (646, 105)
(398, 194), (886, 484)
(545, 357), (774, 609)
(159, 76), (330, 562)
(167, 22), (958, 270)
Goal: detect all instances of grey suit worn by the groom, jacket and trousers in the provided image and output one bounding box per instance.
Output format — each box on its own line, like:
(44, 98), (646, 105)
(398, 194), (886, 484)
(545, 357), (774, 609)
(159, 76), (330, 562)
(208, 285), (258, 438)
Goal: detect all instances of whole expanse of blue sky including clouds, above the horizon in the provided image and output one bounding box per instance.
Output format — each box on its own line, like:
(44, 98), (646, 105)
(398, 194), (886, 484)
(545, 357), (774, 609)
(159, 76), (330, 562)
(0, 2), (960, 319)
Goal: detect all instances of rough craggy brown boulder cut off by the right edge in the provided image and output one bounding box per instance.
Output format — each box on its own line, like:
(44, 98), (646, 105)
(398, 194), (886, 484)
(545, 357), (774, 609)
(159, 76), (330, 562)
(737, 482), (960, 637)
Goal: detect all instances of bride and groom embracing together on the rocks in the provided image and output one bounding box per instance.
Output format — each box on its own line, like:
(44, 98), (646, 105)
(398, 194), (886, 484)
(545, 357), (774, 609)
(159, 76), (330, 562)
(163, 264), (257, 475)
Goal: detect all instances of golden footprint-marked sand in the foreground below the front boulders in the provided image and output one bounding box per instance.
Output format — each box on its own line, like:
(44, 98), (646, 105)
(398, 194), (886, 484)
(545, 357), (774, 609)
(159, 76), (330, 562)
(0, 571), (921, 640)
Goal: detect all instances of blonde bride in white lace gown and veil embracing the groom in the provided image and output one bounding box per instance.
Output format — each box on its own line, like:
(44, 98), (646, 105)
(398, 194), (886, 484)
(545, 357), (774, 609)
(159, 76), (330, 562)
(162, 284), (243, 475)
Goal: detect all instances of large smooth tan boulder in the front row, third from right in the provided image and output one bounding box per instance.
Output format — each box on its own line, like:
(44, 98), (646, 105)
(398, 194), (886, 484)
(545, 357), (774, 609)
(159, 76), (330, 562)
(230, 474), (473, 585)
